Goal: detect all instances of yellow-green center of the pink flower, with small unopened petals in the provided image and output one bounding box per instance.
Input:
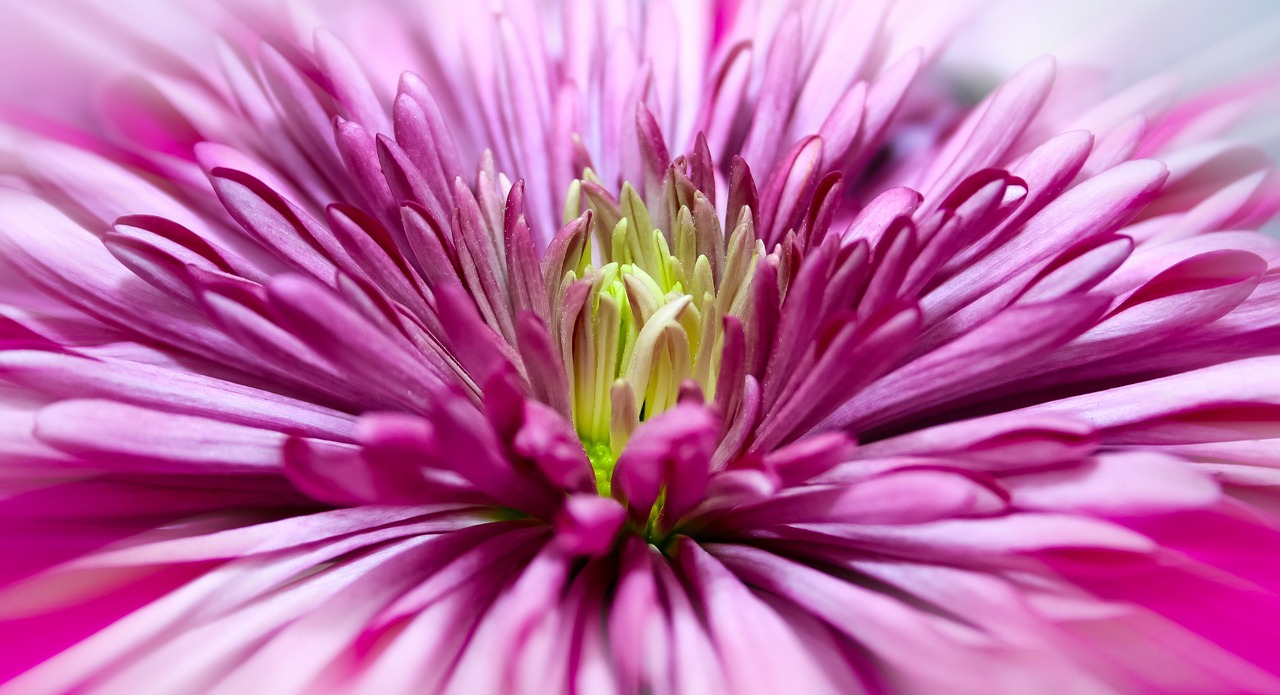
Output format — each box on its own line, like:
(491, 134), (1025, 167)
(550, 176), (764, 495)
